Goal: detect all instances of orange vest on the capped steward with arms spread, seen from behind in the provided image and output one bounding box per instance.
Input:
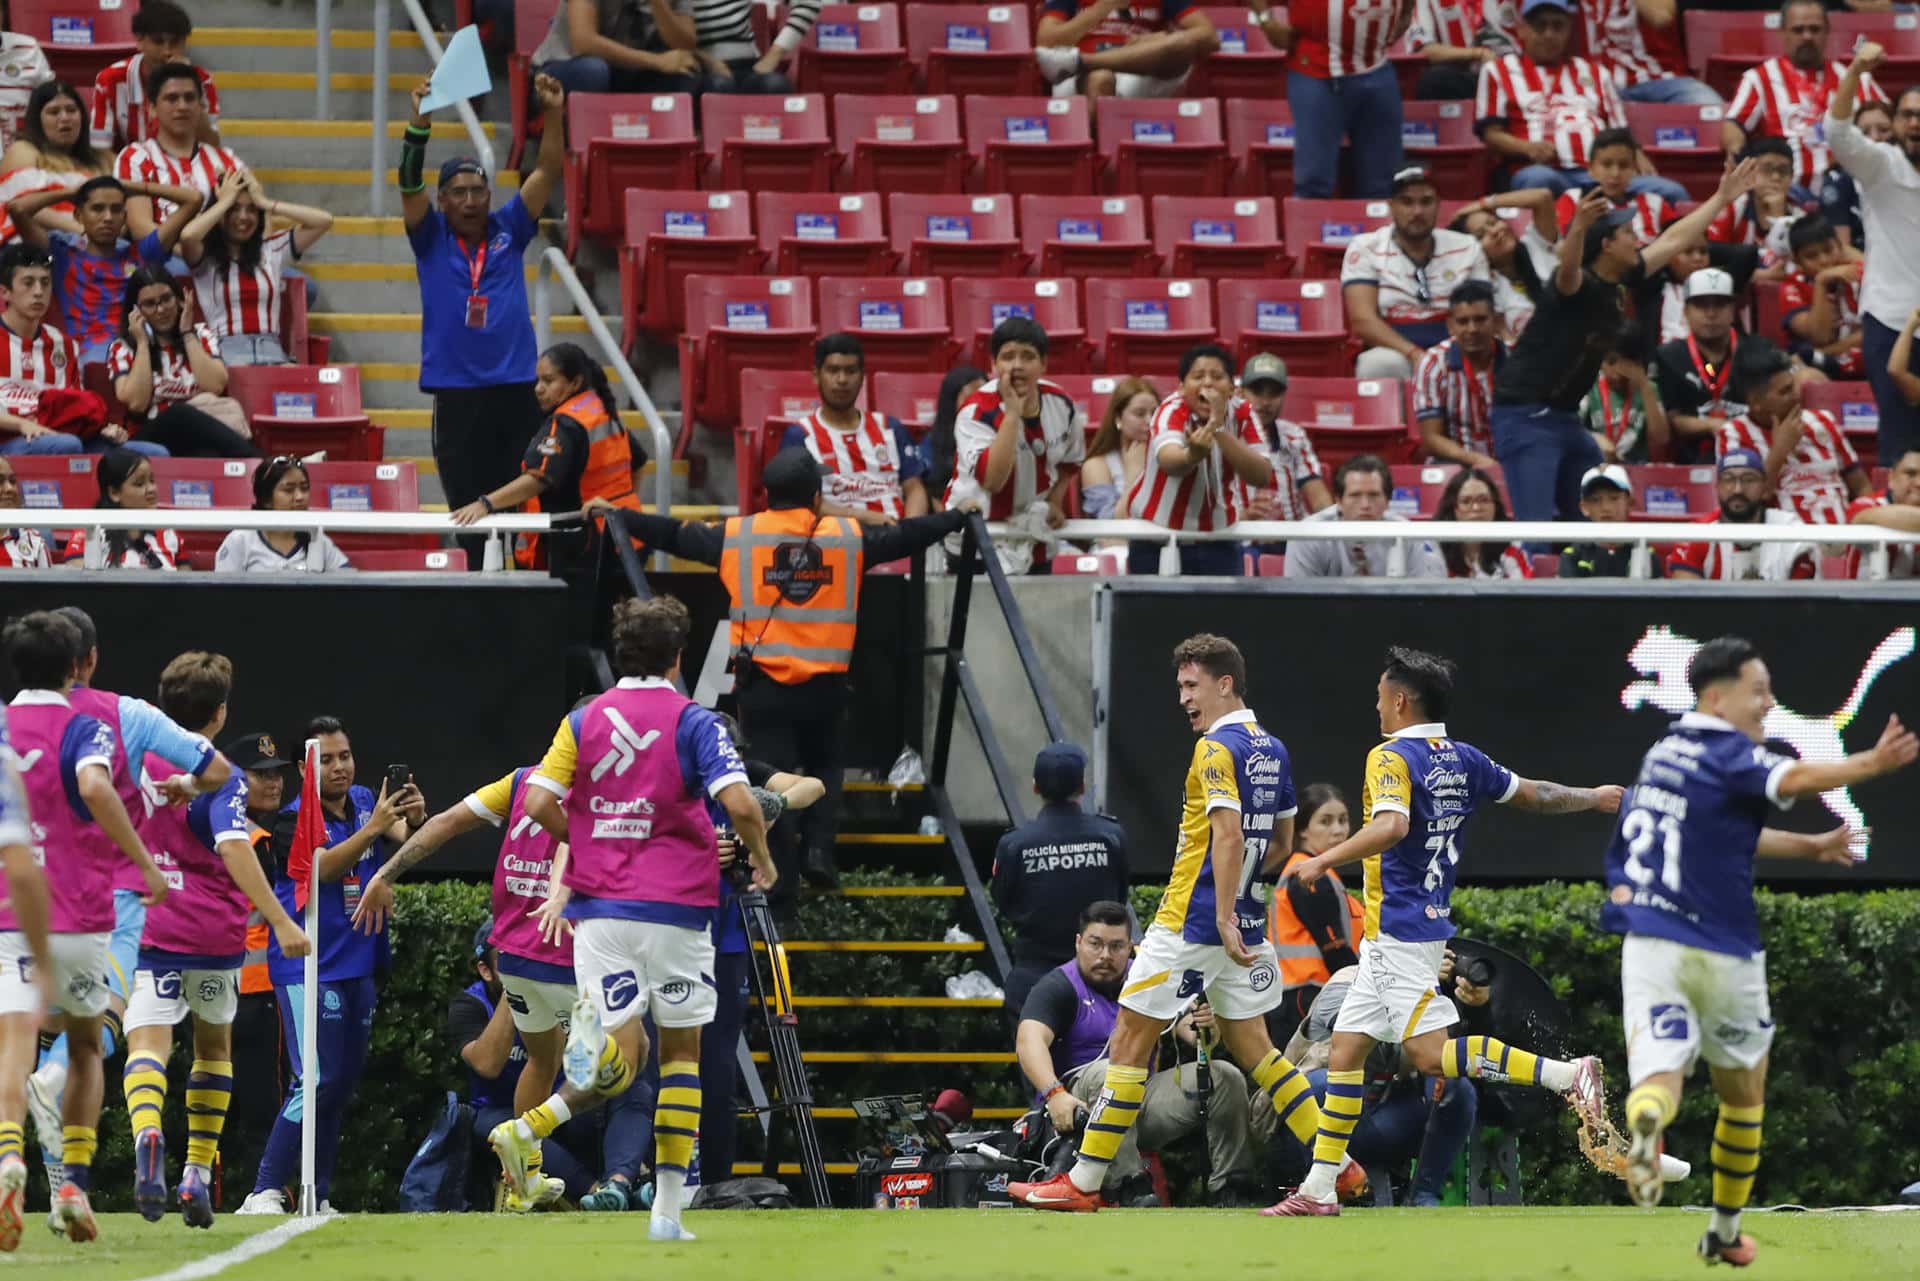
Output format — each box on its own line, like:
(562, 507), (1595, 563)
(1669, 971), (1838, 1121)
(720, 507), (866, 686)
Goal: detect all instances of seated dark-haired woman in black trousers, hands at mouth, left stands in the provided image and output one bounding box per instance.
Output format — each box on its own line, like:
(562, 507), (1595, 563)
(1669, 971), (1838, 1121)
(108, 267), (259, 459)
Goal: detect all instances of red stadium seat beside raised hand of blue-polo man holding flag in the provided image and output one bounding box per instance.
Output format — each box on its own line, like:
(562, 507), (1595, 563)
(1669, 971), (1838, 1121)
(564, 94), (699, 257)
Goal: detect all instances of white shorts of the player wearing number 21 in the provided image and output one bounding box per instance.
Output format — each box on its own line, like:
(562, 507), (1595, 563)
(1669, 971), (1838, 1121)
(1620, 933), (1774, 1085)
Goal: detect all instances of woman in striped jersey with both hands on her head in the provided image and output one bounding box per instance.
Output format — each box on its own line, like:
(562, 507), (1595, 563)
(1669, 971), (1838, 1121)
(180, 169), (334, 365)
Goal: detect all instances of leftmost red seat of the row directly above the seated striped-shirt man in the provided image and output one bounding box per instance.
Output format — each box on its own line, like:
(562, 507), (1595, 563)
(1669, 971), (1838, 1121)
(674, 275), (814, 445)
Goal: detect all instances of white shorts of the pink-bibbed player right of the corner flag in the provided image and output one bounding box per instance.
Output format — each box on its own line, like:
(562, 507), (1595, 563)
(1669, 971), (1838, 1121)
(574, 916), (720, 1029)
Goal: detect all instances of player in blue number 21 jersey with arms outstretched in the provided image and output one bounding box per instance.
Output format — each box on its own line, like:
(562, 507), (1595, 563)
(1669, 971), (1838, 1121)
(1599, 636), (1920, 1268)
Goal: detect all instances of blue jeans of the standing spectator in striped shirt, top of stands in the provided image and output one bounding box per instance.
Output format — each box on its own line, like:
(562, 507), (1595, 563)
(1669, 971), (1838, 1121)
(1286, 63), (1405, 200)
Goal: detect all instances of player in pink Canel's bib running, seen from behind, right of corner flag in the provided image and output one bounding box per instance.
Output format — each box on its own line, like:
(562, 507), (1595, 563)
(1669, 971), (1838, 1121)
(488, 595), (778, 1241)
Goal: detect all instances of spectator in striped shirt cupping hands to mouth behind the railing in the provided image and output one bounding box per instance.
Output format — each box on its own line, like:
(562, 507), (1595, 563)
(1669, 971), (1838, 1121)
(1127, 342), (1273, 576)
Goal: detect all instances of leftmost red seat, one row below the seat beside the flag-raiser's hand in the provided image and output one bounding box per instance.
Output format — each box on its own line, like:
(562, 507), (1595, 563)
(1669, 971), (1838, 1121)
(620, 188), (766, 338)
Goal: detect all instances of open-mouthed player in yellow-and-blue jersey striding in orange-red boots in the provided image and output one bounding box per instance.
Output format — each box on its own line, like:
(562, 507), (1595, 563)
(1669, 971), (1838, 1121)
(1008, 634), (1365, 1212)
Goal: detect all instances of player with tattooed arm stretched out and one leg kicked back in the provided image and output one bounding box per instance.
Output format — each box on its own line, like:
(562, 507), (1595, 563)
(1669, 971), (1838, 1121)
(1261, 645), (1620, 1218)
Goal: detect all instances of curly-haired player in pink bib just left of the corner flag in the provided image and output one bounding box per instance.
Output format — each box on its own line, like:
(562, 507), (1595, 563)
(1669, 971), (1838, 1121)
(125, 651), (309, 1227)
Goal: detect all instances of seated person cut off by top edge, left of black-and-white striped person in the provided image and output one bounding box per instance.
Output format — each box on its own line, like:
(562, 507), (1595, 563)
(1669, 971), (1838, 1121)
(537, 0), (707, 94)
